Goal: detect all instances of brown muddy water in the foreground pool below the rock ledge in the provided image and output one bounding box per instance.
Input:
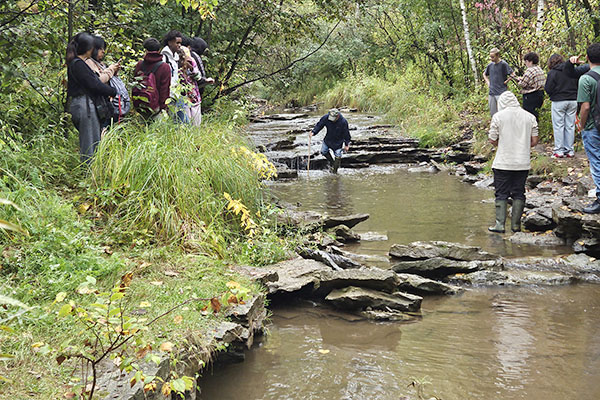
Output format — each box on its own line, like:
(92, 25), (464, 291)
(200, 286), (600, 400)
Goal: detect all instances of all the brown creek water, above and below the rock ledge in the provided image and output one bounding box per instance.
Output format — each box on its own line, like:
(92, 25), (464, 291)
(200, 117), (600, 400)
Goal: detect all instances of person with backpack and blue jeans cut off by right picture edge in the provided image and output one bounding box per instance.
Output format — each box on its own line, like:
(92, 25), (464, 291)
(577, 43), (600, 214)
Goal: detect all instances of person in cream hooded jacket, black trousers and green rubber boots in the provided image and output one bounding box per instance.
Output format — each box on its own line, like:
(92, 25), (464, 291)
(488, 91), (538, 233)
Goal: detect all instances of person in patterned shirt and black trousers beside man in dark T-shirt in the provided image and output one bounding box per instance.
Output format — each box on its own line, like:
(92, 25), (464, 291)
(509, 52), (546, 121)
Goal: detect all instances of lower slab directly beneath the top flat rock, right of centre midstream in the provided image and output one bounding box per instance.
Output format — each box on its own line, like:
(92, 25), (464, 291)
(392, 257), (503, 277)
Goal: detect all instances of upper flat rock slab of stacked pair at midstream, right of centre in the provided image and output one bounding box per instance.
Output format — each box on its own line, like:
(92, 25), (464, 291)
(389, 241), (498, 261)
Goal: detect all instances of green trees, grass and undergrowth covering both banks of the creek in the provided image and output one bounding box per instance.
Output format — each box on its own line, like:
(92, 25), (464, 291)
(0, 0), (600, 398)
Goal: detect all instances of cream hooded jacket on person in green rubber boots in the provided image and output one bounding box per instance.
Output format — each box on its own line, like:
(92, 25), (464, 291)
(488, 91), (538, 171)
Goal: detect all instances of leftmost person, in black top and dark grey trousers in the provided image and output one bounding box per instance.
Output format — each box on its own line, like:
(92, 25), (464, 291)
(66, 32), (117, 164)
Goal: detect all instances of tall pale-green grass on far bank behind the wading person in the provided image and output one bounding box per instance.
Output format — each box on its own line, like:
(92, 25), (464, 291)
(323, 65), (474, 147)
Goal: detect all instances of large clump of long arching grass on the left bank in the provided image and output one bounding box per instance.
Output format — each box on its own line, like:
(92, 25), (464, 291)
(90, 117), (262, 250)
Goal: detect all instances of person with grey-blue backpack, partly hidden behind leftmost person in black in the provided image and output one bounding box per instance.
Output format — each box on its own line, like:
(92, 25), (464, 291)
(86, 36), (131, 128)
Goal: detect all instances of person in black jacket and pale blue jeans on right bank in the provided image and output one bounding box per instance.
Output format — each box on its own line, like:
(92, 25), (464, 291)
(544, 54), (577, 158)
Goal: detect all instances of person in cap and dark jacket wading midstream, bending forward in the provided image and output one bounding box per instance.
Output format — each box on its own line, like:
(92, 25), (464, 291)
(309, 108), (350, 174)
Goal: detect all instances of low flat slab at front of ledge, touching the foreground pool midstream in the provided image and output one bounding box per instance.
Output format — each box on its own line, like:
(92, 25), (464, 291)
(325, 287), (423, 311)
